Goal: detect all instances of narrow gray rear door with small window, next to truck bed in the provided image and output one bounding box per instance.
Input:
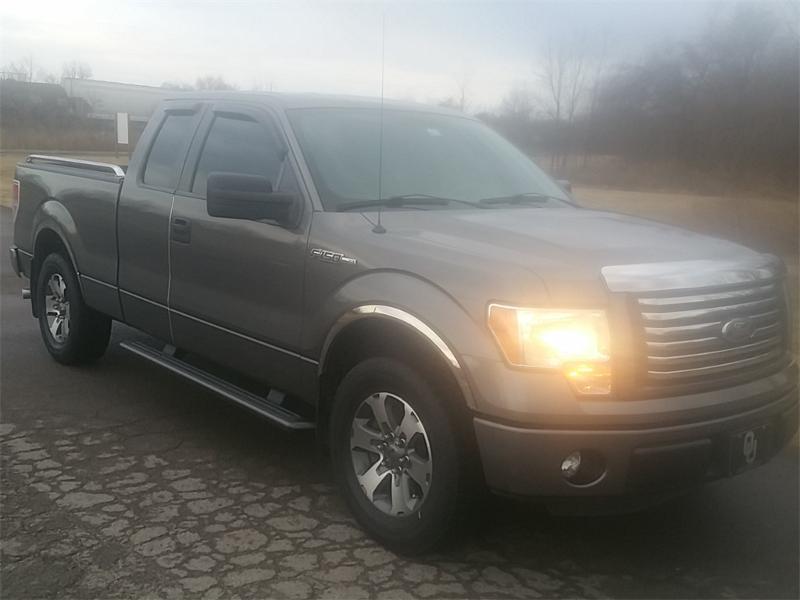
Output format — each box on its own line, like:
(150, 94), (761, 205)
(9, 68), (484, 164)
(117, 101), (203, 341)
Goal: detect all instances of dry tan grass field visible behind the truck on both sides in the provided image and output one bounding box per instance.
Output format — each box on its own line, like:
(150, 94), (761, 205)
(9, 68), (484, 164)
(0, 152), (800, 340)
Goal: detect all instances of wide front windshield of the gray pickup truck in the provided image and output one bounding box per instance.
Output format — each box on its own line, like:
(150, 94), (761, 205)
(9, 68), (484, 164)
(288, 107), (570, 210)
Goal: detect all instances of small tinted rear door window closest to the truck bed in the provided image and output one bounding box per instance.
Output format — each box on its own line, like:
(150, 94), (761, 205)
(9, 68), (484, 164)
(142, 114), (194, 189)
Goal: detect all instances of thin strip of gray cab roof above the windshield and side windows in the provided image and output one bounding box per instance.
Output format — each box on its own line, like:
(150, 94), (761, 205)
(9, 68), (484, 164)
(159, 92), (467, 117)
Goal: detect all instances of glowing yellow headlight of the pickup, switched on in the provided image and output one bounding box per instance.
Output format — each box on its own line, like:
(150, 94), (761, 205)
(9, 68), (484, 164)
(489, 304), (611, 394)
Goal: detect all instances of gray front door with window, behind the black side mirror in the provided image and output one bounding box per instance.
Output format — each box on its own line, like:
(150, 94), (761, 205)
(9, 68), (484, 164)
(169, 103), (314, 393)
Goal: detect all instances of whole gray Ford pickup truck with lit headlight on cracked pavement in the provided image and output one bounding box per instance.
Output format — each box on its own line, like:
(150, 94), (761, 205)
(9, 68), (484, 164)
(11, 93), (798, 553)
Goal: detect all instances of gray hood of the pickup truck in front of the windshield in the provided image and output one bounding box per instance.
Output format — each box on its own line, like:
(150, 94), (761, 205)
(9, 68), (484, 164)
(382, 208), (757, 302)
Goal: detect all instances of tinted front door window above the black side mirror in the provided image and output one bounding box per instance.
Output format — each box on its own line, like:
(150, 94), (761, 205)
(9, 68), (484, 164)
(192, 117), (283, 196)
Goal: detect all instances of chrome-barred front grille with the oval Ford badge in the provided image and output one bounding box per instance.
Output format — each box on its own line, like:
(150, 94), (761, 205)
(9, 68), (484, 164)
(635, 280), (787, 395)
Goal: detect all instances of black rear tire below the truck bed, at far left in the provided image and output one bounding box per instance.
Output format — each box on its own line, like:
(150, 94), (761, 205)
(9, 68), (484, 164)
(35, 253), (111, 365)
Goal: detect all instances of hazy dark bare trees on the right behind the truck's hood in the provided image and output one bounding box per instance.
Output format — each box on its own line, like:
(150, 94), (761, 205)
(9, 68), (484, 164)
(480, 5), (800, 190)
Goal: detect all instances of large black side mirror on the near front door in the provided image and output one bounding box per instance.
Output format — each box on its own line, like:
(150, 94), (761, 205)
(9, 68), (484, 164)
(206, 171), (300, 227)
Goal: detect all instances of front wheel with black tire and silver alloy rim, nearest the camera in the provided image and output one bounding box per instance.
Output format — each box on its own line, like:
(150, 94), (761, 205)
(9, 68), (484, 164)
(331, 358), (475, 554)
